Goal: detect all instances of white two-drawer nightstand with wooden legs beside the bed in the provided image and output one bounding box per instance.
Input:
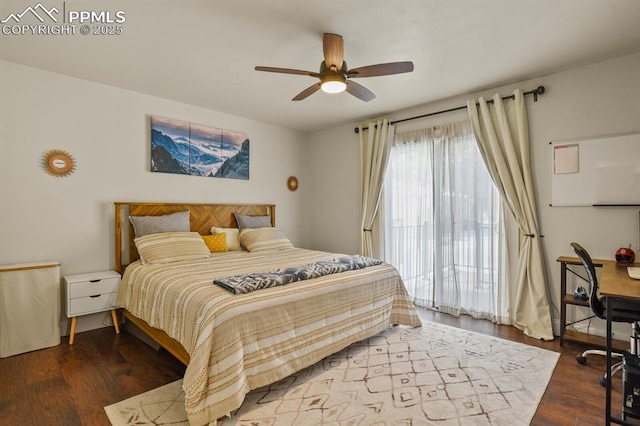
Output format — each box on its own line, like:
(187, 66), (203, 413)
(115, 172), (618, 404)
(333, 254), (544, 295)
(64, 271), (120, 345)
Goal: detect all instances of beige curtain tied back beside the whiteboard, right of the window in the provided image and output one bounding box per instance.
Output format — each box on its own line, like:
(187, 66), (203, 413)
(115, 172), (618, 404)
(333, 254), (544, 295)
(467, 90), (554, 340)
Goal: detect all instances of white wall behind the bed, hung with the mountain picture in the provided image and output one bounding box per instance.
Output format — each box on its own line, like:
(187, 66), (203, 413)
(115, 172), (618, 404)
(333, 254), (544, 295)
(0, 61), (309, 331)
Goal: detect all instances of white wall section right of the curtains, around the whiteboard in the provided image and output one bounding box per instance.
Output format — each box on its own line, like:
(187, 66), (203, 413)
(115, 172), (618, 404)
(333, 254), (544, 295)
(529, 55), (640, 338)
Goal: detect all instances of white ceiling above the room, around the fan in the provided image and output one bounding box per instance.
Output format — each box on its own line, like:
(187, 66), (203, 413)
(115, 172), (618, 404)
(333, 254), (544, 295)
(0, 0), (640, 131)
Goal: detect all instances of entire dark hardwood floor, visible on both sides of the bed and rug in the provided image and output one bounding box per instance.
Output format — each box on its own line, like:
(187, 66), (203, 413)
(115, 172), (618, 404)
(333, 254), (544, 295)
(0, 310), (622, 426)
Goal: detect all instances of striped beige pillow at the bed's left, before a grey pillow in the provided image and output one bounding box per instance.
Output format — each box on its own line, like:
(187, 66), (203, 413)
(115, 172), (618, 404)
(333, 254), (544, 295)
(133, 232), (211, 263)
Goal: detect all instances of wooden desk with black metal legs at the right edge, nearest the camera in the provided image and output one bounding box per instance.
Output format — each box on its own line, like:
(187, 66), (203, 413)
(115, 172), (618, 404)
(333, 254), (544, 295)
(600, 260), (640, 425)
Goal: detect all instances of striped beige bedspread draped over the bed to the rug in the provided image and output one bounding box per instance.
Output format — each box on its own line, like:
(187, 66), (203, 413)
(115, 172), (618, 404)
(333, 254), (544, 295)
(117, 248), (421, 425)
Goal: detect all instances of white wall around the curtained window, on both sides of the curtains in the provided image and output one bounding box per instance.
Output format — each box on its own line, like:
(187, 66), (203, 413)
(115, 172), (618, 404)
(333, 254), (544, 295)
(309, 54), (640, 340)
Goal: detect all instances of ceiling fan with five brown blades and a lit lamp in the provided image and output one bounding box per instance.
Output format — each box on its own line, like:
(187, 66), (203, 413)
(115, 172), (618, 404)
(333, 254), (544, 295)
(256, 33), (413, 102)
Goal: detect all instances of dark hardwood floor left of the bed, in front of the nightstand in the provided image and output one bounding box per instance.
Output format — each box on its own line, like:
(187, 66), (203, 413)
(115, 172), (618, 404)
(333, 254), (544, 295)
(0, 327), (185, 426)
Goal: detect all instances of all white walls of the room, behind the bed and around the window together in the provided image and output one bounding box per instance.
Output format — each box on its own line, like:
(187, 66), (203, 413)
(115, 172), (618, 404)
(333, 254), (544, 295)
(0, 55), (640, 340)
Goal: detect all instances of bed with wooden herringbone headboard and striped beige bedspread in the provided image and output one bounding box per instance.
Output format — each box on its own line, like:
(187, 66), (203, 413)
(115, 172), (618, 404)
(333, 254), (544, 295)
(115, 202), (421, 425)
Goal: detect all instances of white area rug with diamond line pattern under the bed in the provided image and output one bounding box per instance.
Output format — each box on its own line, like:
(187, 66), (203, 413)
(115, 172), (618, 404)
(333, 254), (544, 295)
(105, 320), (560, 426)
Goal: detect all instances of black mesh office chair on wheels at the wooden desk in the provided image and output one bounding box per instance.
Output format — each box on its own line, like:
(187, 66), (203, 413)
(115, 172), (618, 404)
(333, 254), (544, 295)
(571, 243), (640, 386)
